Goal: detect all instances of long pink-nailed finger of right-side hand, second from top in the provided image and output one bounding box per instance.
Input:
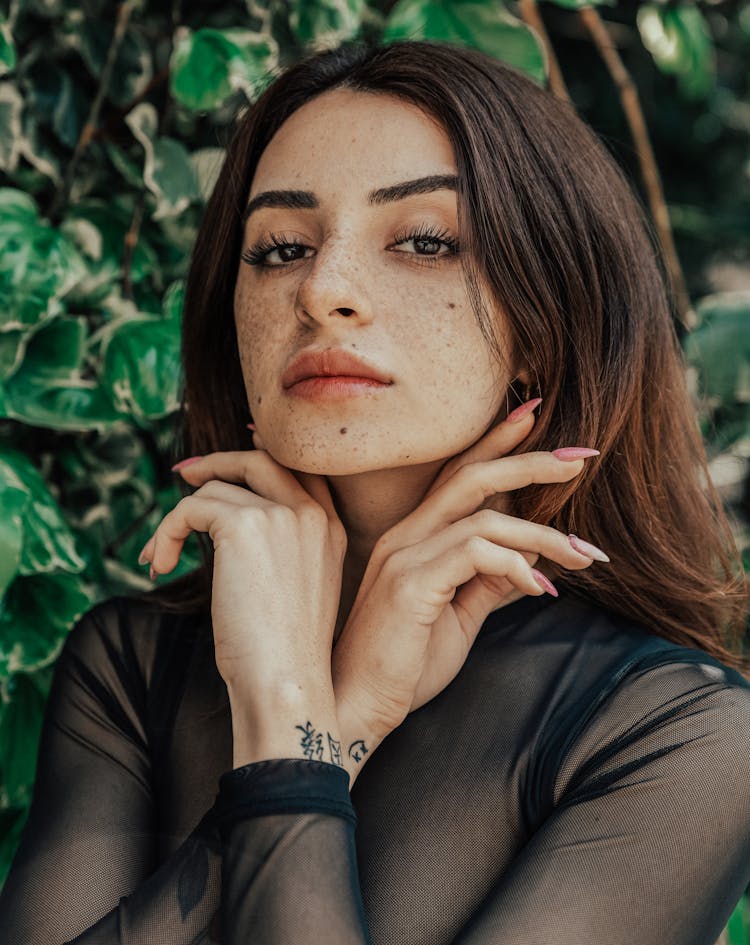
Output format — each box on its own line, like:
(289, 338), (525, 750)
(383, 452), (600, 552)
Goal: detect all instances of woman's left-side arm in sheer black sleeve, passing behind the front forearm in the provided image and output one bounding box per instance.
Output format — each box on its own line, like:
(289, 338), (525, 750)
(0, 603), (221, 945)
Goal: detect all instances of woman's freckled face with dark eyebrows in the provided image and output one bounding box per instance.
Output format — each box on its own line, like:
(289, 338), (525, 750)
(234, 89), (509, 475)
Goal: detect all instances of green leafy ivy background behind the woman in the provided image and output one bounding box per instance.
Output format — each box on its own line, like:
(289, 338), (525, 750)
(0, 0), (750, 945)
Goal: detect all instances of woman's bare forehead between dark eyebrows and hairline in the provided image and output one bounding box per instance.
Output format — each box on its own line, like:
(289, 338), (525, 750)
(250, 89), (456, 197)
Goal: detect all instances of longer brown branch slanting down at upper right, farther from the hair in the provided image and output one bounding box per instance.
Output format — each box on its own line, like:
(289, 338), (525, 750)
(578, 7), (697, 329)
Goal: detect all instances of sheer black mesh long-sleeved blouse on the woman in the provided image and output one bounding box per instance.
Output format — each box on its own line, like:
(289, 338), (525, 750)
(0, 591), (750, 945)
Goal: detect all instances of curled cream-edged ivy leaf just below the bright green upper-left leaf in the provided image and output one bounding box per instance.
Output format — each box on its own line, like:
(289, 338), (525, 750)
(125, 102), (200, 220)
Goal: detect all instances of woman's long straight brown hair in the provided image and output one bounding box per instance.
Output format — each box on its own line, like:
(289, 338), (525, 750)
(140, 42), (747, 671)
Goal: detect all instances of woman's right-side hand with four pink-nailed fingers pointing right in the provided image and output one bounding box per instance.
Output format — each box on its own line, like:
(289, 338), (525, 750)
(332, 417), (608, 740)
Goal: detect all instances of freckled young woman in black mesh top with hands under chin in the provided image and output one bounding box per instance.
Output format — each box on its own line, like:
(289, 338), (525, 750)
(0, 43), (750, 945)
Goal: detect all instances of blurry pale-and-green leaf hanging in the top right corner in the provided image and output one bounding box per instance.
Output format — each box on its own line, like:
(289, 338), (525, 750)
(636, 3), (716, 99)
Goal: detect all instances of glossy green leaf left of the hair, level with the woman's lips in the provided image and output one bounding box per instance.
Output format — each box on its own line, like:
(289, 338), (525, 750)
(103, 318), (181, 420)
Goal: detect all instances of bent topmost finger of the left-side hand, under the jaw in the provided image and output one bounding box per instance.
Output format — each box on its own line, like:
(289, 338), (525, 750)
(177, 450), (318, 509)
